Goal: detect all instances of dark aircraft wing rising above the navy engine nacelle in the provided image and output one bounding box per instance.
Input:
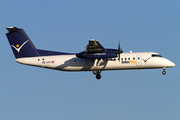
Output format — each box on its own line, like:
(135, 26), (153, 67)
(86, 40), (105, 53)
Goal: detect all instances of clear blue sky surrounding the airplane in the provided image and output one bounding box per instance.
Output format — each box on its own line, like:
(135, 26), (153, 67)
(0, 0), (180, 120)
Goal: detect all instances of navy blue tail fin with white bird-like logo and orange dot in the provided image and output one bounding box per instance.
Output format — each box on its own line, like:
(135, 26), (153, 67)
(6, 27), (40, 58)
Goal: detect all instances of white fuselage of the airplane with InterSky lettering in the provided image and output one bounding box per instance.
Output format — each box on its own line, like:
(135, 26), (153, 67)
(16, 52), (175, 71)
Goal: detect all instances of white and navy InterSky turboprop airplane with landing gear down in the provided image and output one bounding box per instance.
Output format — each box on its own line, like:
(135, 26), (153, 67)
(6, 27), (175, 79)
